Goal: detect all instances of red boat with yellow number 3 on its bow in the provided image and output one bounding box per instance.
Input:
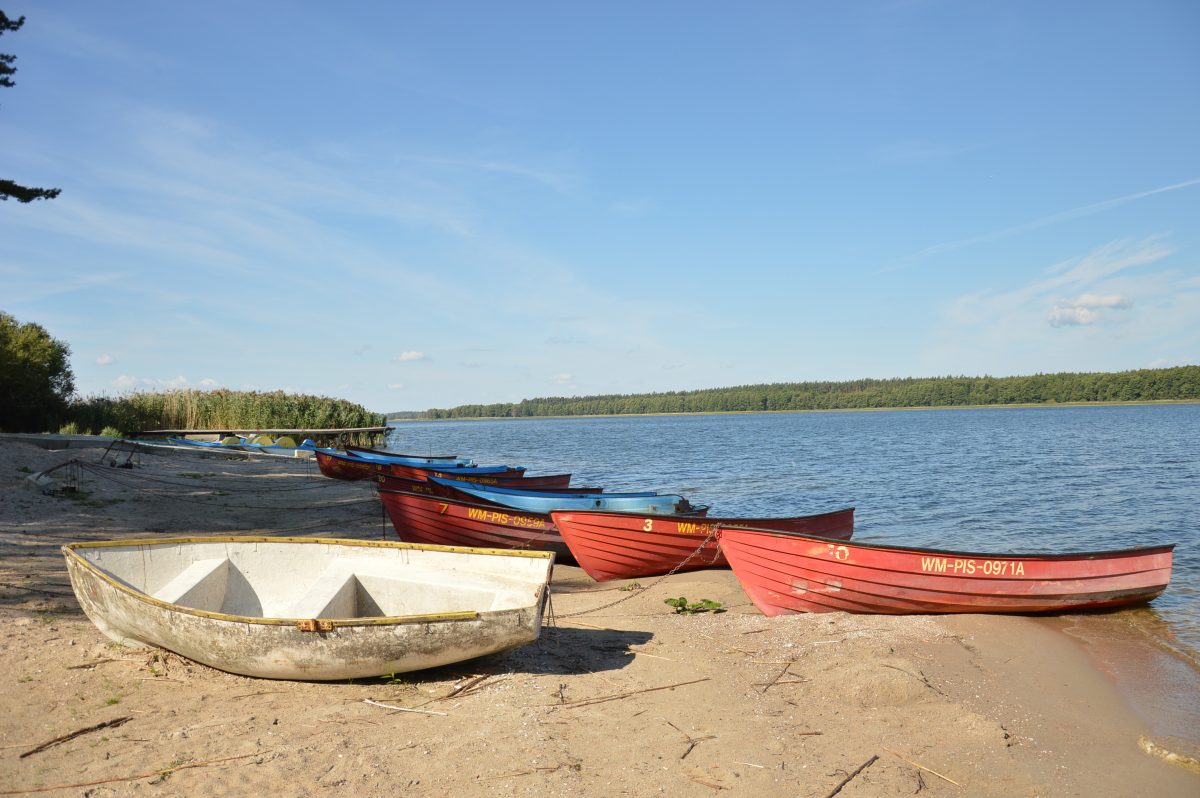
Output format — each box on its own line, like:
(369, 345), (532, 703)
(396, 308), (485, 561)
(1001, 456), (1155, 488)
(550, 508), (854, 582)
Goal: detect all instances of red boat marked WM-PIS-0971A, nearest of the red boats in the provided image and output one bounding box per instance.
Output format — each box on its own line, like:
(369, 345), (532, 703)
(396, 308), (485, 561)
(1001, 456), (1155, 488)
(719, 526), (1175, 616)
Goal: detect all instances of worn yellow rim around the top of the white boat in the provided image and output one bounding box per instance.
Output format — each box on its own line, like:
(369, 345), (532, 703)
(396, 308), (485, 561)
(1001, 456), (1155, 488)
(61, 535), (554, 629)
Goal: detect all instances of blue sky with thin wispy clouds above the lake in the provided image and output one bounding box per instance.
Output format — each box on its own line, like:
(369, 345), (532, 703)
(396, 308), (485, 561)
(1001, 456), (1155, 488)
(0, 0), (1200, 412)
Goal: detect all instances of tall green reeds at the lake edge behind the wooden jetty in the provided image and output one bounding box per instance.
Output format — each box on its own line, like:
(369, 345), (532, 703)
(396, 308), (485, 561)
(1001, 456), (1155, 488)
(68, 390), (386, 434)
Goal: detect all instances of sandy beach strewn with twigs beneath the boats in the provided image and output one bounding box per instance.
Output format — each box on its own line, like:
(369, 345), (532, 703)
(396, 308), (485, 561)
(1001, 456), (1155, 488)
(0, 440), (1200, 798)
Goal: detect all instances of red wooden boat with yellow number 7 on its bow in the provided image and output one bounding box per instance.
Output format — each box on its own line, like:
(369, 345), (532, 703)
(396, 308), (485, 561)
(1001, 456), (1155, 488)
(379, 488), (571, 559)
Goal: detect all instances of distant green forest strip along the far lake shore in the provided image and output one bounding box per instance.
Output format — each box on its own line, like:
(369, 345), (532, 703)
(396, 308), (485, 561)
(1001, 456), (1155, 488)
(405, 366), (1200, 419)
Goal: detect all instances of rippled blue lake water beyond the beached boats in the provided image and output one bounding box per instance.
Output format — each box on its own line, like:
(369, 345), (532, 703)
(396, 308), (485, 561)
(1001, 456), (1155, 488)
(389, 404), (1200, 655)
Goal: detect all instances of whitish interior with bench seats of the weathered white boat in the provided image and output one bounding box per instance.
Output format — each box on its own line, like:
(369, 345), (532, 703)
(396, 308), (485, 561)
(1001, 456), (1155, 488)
(76, 539), (548, 619)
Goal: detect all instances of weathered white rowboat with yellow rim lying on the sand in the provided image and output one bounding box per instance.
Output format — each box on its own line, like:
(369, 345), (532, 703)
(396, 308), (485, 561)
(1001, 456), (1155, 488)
(62, 536), (554, 680)
